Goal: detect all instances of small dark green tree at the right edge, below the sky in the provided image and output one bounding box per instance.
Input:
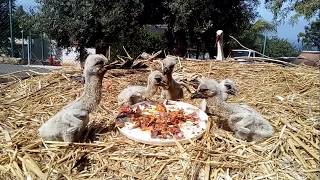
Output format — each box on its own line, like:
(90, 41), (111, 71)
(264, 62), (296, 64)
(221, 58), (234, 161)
(298, 19), (320, 51)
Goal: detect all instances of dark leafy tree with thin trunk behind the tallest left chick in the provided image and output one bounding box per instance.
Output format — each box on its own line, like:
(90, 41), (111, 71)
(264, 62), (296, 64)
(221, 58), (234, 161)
(38, 0), (143, 67)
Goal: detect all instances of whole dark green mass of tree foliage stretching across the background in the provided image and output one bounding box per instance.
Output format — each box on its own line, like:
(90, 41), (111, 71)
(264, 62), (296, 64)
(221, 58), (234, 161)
(1, 0), (275, 59)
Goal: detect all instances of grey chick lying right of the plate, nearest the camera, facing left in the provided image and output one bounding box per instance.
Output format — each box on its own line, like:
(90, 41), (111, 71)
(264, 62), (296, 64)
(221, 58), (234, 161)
(192, 80), (273, 141)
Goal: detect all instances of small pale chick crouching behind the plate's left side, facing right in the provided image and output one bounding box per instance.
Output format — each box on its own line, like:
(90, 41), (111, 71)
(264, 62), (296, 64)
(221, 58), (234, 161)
(117, 71), (167, 106)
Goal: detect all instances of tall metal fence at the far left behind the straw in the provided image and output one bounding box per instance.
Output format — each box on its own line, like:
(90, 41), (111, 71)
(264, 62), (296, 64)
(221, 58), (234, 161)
(0, 0), (55, 64)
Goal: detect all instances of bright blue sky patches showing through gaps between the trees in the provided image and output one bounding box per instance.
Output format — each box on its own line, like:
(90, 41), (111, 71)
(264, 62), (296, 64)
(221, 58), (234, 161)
(16, 0), (309, 47)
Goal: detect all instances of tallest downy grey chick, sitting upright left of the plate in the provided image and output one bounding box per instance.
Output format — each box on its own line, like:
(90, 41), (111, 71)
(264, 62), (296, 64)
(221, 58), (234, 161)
(39, 55), (108, 143)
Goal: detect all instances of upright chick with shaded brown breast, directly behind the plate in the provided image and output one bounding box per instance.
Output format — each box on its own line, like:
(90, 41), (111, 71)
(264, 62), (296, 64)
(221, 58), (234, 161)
(161, 56), (183, 101)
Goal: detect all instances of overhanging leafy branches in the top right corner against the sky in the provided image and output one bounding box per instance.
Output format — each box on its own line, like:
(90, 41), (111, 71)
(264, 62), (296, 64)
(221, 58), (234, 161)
(265, 0), (320, 20)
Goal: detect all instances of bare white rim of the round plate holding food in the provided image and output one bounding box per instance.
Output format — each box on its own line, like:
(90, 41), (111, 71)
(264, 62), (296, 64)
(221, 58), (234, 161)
(119, 101), (208, 145)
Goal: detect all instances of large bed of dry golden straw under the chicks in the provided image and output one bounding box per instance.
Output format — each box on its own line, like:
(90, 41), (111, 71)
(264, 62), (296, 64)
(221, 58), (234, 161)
(0, 61), (320, 179)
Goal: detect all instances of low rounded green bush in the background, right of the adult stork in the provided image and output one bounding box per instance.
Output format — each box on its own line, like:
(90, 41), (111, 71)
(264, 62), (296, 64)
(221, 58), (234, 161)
(266, 37), (298, 58)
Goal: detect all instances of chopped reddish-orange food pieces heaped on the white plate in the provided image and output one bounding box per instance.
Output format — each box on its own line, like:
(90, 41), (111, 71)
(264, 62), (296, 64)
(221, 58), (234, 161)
(116, 103), (199, 139)
